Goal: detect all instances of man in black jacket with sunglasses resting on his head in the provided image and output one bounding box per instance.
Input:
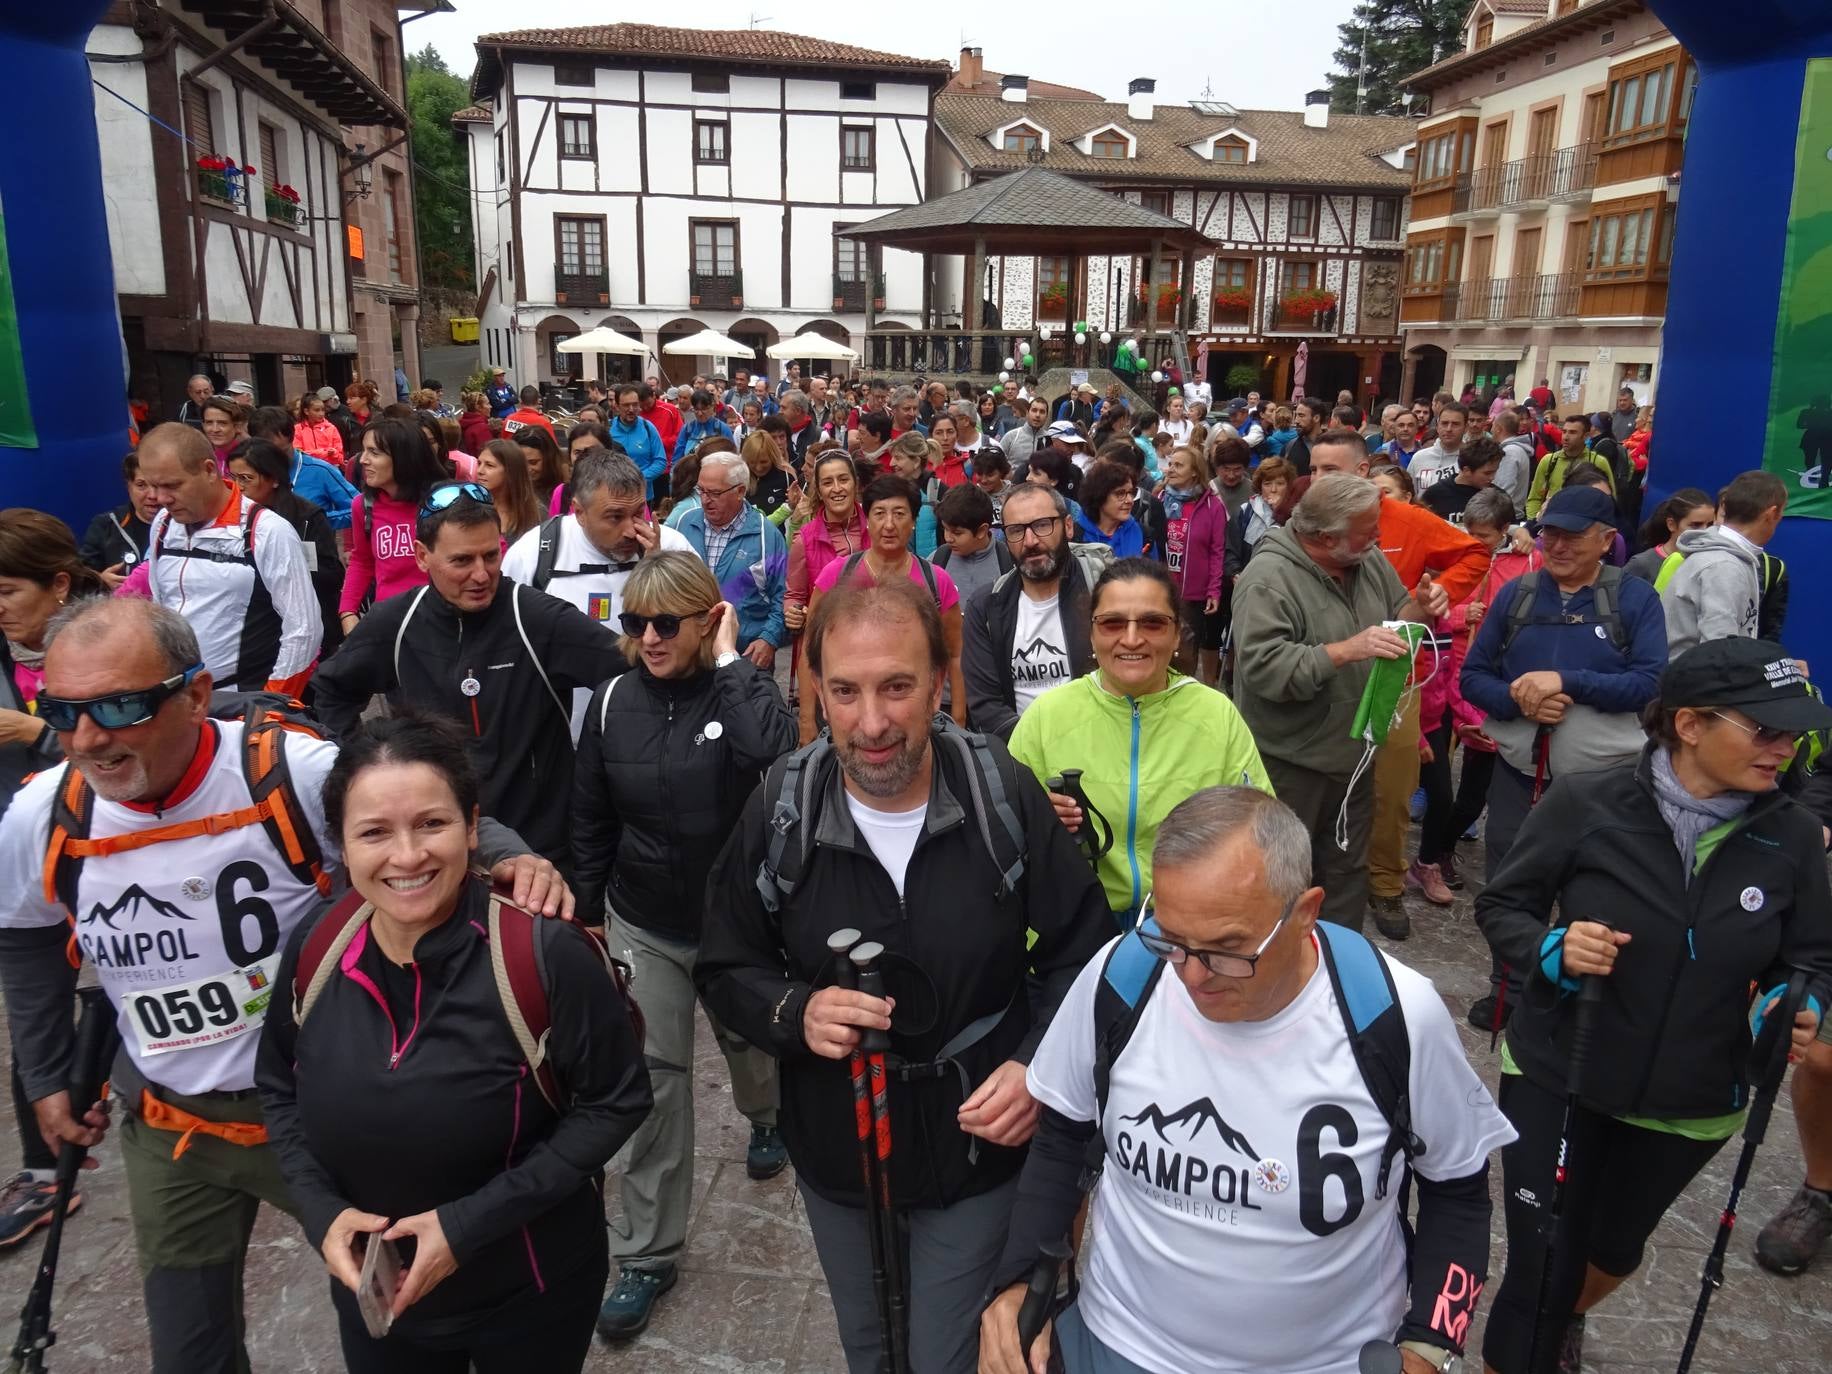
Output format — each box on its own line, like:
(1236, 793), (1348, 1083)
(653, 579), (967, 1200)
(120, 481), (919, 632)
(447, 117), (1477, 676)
(315, 487), (628, 868)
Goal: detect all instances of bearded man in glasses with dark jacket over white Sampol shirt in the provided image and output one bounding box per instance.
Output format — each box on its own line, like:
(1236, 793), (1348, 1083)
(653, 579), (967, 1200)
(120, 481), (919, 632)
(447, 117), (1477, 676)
(960, 482), (1112, 740)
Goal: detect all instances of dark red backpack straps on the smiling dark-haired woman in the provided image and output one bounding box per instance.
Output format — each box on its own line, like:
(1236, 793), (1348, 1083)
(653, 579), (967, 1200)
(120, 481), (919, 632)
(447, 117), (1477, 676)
(293, 892), (647, 1112)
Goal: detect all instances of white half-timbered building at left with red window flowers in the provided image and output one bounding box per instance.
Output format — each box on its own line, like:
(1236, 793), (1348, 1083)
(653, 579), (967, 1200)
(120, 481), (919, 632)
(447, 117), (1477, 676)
(88, 0), (407, 421)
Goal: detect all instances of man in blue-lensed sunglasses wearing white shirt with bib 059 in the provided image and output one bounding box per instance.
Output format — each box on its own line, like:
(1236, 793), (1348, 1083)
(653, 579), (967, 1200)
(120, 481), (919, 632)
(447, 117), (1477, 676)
(0, 597), (572, 1374)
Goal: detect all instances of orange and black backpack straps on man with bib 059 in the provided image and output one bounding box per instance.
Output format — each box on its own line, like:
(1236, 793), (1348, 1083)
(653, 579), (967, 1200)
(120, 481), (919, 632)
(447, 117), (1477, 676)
(44, 692), (332, 914)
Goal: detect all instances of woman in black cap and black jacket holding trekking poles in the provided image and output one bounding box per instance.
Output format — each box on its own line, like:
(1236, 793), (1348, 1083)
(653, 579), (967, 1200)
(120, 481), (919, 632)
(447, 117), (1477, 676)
(1477, 639), (1832, 1374)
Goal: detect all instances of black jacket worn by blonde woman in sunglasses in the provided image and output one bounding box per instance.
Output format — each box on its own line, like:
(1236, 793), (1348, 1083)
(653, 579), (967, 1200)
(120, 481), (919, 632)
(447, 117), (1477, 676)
(572, 658), (795, 940)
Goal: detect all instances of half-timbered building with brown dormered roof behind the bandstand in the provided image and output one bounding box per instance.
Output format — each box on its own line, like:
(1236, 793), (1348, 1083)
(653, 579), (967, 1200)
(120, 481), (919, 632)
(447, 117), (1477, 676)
(932, 48), (1414, 414)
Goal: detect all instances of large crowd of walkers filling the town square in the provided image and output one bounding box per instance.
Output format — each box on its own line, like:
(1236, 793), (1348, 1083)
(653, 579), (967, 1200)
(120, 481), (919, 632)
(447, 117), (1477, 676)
(0, 365), (1832, 1374)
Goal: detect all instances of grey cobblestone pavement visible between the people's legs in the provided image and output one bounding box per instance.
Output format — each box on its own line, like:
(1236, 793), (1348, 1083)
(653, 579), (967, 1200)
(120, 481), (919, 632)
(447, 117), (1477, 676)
(0, 846), (1832, 1374)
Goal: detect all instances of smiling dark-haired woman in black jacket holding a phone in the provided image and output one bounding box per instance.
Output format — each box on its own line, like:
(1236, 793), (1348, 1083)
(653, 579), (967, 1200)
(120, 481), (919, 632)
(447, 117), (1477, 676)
(255, 716), (650, 1374)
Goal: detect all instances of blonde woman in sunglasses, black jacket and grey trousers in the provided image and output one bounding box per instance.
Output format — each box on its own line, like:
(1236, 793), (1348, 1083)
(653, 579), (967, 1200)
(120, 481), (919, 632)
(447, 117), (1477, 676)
(572, 553), (795, 1339)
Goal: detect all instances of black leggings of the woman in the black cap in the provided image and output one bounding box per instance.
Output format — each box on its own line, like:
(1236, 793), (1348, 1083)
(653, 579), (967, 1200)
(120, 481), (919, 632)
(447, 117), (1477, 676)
(1482, 1074), (1724, 1374)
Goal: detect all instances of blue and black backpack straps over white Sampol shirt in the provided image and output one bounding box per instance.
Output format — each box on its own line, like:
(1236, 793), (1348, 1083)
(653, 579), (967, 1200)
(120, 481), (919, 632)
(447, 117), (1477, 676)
(1081, 918), (1425, 1211)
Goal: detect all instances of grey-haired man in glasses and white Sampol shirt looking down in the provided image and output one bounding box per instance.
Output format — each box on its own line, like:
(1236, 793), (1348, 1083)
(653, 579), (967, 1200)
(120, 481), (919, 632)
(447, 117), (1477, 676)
(980, 788), (1513, 1374)
